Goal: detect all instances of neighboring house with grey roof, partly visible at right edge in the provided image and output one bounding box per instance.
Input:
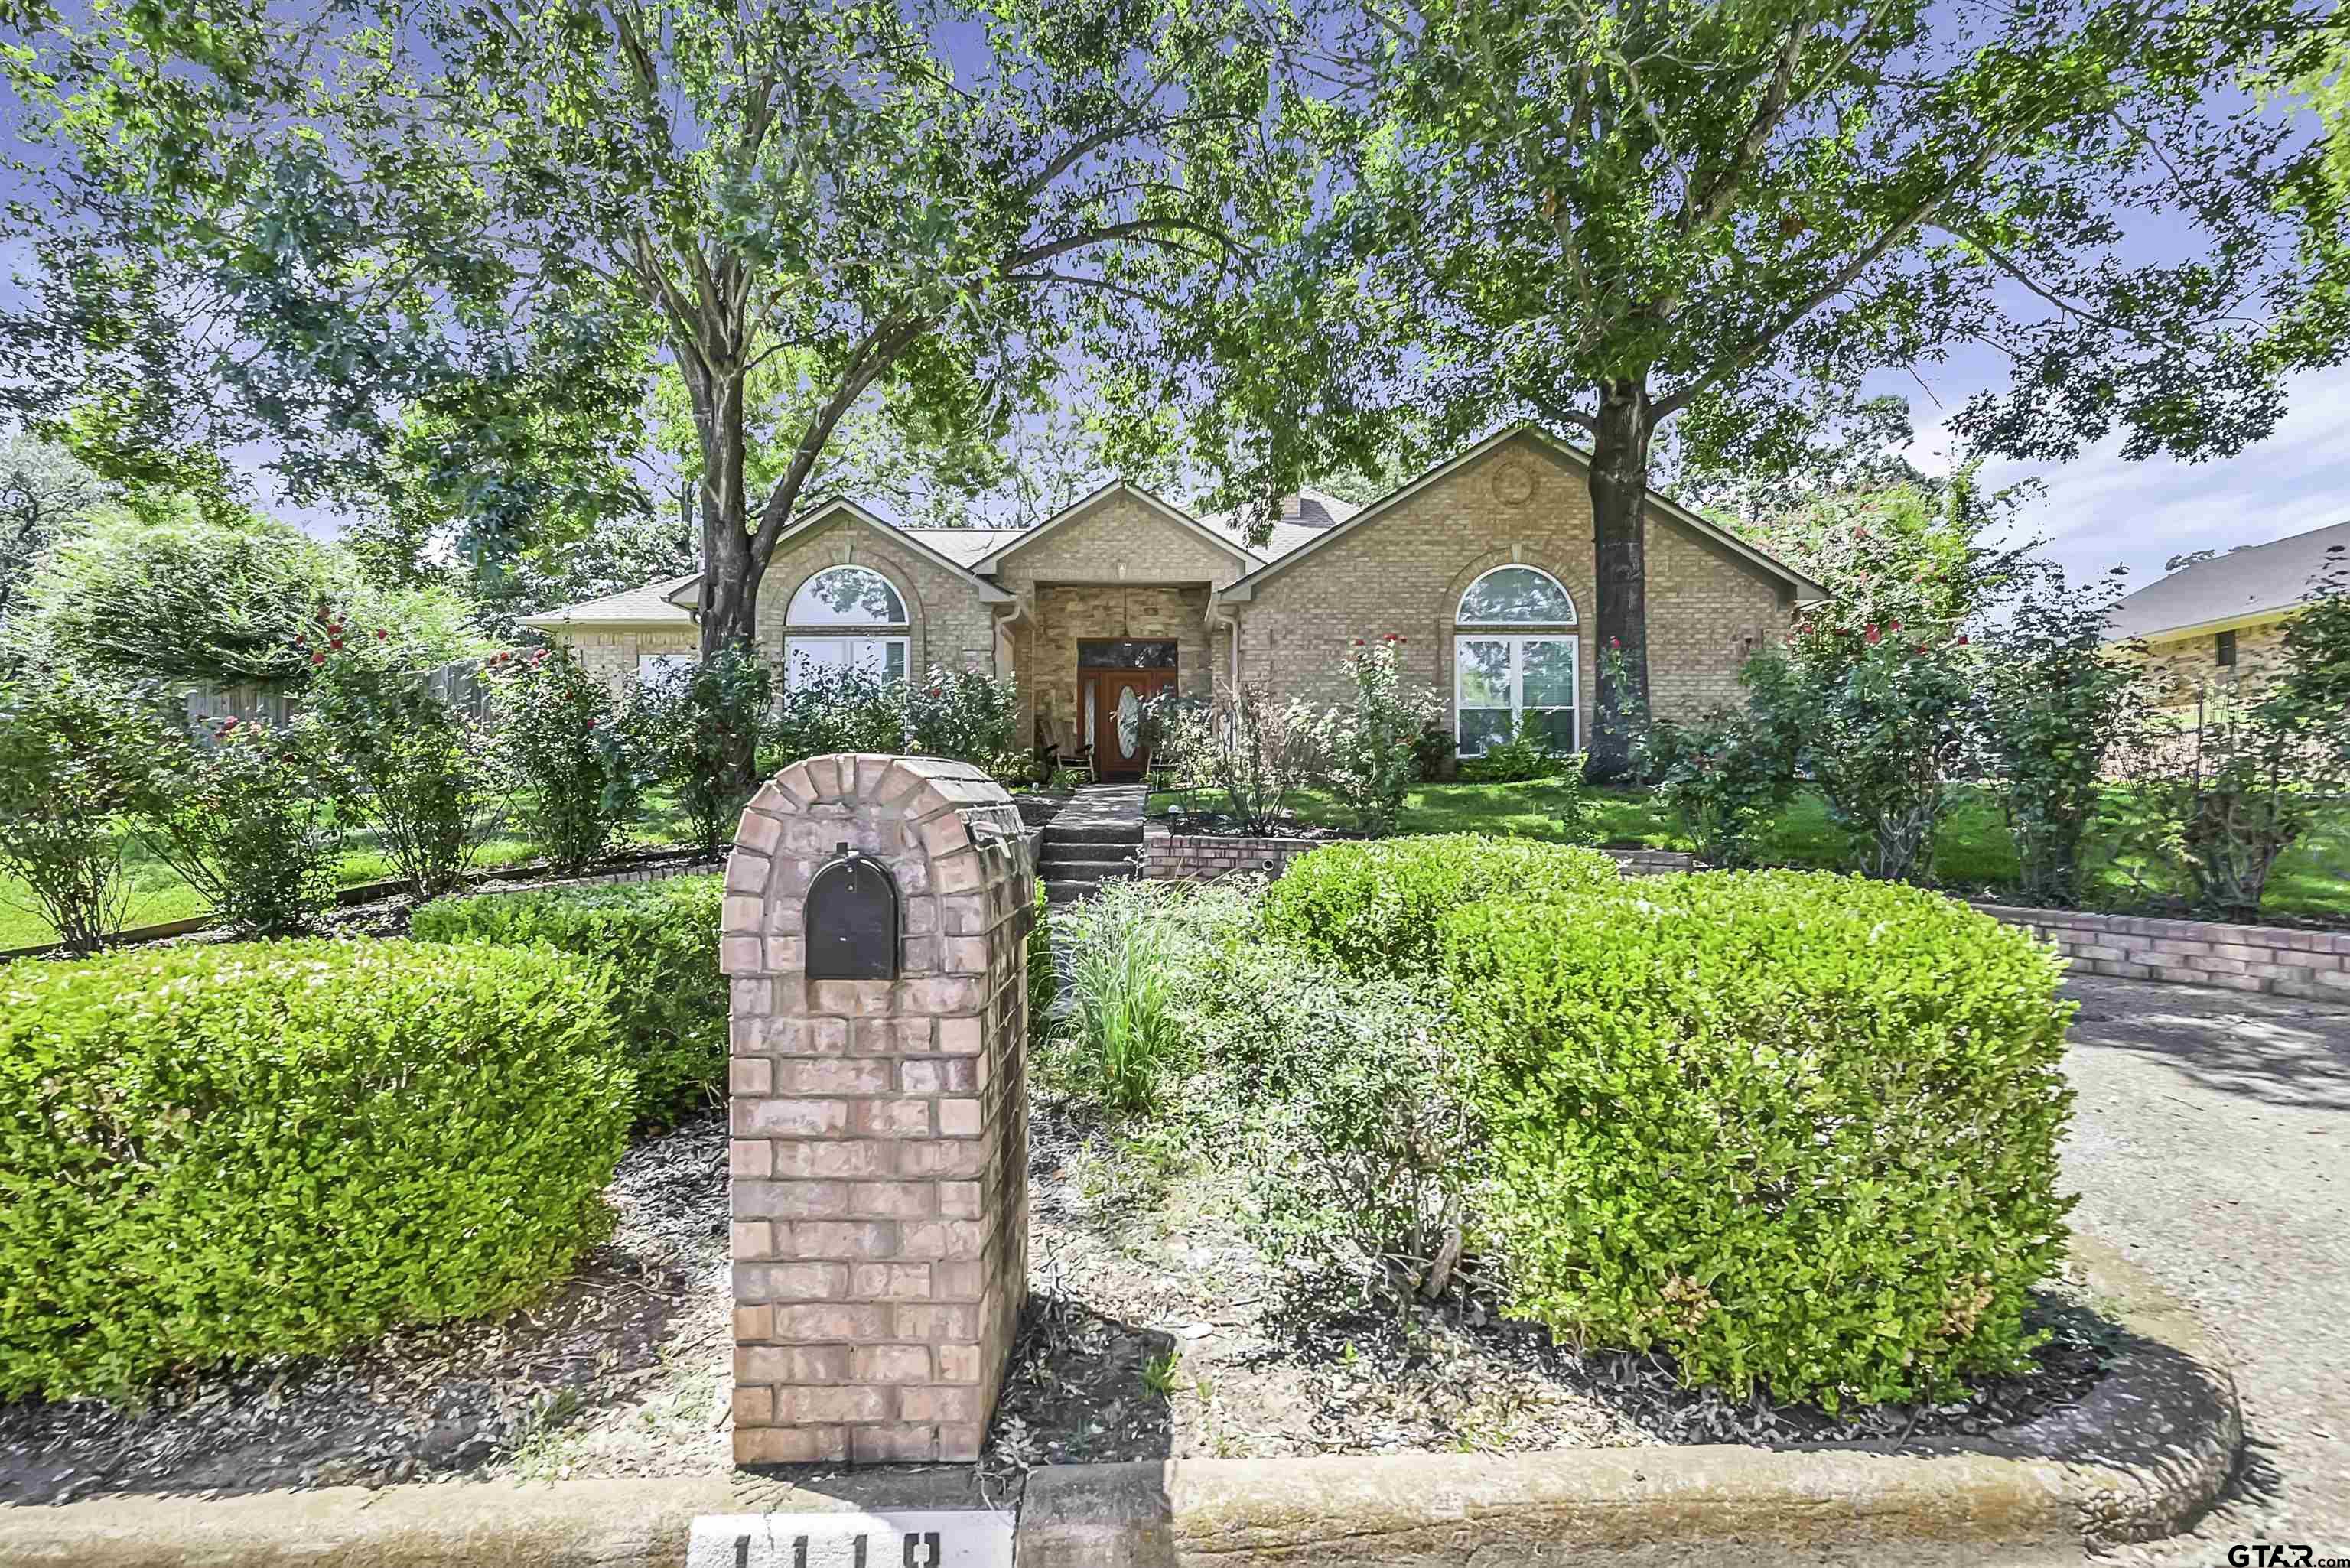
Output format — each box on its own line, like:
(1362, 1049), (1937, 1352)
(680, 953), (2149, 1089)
(2108, 522), (2350, 703)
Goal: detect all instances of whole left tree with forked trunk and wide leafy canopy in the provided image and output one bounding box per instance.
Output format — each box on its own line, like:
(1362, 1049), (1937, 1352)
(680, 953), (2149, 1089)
(0, 0), (1302, 761)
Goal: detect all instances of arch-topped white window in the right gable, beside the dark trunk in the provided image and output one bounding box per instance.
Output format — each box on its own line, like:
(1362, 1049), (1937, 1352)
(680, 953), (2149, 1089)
(1452, 564), (1579, 757)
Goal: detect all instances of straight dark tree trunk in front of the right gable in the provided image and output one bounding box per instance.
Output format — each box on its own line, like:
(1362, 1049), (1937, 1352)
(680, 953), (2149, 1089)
(1584, 379), (1655, 782)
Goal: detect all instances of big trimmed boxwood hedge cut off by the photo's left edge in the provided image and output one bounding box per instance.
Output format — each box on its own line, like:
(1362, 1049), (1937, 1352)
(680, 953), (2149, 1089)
(0, 940), (630, 1399)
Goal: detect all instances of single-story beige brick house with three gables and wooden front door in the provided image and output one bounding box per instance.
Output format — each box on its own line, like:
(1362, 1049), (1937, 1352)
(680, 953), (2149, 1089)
(526, 428), (1824, 778)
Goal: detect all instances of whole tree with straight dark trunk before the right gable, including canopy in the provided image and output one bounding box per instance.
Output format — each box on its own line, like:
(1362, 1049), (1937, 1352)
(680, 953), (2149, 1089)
(1259, 0), (2350, 771)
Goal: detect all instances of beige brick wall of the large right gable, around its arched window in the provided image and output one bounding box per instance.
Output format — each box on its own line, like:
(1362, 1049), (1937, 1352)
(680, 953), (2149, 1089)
(1217, 438), (1793, 745)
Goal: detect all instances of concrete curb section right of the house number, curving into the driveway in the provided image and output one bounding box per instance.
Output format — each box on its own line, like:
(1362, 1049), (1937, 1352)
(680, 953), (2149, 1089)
(1017, 1237), (2244, 1568)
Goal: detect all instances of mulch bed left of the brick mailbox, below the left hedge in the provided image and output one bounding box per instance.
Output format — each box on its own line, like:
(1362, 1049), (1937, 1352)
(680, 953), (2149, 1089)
(0, 1114), (731, 1502)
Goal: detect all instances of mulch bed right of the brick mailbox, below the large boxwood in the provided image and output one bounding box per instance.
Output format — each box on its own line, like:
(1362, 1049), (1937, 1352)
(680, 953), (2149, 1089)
(987, 1105), (2113, 1483)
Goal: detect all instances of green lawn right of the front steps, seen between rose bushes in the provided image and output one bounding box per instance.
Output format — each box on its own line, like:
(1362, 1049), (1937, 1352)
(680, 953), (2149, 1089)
(1149, 778), (2350, 919)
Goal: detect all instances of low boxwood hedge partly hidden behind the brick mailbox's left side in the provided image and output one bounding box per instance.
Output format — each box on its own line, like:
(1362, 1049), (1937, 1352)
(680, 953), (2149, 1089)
(412, 877), (726, 1126)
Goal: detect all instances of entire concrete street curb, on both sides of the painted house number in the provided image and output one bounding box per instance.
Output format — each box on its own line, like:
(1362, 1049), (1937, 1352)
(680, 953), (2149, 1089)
(0, 1237), (2244, 1568)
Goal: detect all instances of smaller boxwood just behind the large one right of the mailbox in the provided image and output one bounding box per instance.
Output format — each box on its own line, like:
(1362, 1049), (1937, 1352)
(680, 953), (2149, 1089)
(1265, 832), (1619, 975)
